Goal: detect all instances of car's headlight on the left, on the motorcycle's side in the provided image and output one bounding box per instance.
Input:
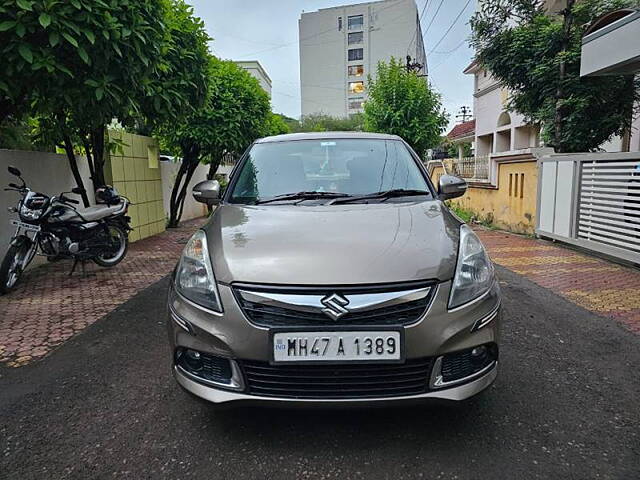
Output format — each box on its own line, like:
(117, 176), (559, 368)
(174, 230), (222, 312)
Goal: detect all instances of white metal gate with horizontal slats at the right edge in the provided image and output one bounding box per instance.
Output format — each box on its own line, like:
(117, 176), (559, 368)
(536, 152), (640, 264)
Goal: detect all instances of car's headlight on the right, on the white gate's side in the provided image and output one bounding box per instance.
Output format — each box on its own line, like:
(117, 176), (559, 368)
(449, 225), (494, 308)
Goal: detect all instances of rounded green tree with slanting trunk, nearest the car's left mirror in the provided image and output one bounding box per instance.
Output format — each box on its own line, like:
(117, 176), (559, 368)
(163, 57), (274, 227)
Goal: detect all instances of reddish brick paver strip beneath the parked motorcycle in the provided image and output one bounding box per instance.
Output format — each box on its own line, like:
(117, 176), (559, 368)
(0, 219), (204, 367)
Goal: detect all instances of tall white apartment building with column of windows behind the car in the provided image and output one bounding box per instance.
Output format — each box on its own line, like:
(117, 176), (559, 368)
(299, 0), (427, 117)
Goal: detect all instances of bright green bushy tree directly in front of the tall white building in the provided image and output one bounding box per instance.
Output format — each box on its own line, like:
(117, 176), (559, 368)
(364, 58), (448, 155)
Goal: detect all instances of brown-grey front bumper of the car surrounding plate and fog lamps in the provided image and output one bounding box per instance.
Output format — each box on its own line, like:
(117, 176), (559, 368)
(168, 282), (500, 406)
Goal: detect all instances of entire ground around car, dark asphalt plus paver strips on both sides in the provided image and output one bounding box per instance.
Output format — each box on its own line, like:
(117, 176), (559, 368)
(0, 219), (640, 480)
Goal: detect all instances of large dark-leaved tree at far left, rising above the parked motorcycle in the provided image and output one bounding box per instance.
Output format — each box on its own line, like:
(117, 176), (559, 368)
(0, 0), (168, 205)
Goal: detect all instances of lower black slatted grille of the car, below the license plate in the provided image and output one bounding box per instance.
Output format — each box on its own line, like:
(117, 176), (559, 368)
(242, 358), (432, 399)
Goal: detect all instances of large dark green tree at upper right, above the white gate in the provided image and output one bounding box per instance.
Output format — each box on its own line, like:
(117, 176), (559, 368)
(471, 0), (640, 152)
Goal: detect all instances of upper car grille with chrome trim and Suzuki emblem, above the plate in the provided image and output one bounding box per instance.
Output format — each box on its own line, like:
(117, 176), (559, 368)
(234, 283), (436, 327)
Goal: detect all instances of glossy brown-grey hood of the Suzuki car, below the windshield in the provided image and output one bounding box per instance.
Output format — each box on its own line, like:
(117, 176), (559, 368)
(204, 200), (460, 285)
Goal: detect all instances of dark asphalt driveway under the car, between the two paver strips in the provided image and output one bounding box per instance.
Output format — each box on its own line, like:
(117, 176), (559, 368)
(0, 268), (640, 480)
